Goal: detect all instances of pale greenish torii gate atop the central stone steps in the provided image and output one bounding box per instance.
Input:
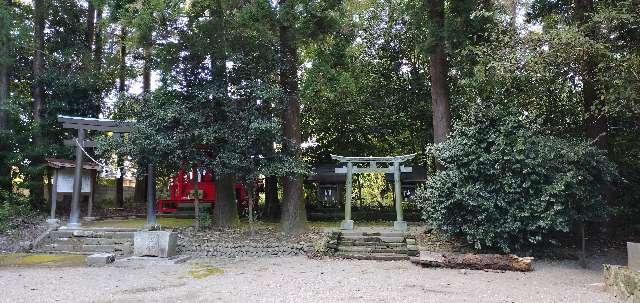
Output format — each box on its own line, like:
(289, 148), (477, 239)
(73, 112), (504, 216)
(331, 154), (416, 231)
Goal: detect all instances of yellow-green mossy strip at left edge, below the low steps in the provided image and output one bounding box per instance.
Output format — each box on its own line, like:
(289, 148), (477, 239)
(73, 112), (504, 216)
(0, 254), (86, 267)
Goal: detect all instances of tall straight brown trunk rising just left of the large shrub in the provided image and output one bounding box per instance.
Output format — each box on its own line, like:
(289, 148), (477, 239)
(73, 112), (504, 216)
(427, 0), (451, 143)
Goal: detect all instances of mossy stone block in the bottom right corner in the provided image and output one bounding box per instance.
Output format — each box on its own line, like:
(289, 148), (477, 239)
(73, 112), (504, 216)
(604, 264), (640, 302)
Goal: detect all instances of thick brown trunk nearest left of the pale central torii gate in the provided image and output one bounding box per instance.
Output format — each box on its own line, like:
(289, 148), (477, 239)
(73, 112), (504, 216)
(279, 0), (307, 234)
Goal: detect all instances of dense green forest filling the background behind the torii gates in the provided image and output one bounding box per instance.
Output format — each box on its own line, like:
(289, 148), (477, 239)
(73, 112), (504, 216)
(0, 0), (640, 250)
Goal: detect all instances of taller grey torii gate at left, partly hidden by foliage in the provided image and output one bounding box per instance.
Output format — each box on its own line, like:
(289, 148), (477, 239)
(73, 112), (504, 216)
(58, 115), (156, 229)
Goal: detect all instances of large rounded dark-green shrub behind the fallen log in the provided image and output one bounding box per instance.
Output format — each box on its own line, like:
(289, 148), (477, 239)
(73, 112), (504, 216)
(415, 104), (615, 252)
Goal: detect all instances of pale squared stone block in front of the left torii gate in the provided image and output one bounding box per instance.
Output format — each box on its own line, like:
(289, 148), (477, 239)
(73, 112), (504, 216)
(133, 231), (178, 258)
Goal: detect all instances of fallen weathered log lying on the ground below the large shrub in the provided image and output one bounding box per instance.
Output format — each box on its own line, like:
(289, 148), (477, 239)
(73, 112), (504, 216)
(411, 251), (533, 271)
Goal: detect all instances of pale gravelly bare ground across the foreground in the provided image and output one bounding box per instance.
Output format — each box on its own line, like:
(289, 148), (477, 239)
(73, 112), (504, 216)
(0, 257), (616, 303)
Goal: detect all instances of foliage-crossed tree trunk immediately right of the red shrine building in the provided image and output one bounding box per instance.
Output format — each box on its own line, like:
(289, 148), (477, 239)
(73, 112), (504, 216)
(210, 0), (238, 227)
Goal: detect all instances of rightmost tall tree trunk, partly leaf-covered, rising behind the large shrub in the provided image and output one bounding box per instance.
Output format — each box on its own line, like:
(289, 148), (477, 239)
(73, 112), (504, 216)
(575, 0), (609, 150)
